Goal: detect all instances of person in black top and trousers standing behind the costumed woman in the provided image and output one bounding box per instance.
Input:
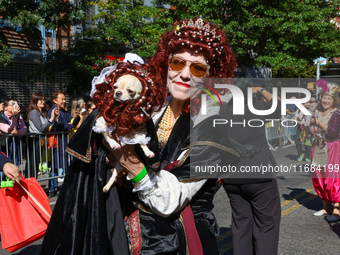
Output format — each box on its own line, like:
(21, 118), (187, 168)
(220, 79), (281, 255)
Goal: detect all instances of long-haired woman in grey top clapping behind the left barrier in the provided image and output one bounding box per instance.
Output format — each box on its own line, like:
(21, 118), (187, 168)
(26, 92), (60, 177)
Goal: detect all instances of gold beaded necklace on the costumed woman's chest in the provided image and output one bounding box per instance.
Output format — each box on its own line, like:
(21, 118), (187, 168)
(157, 105), (179, 154)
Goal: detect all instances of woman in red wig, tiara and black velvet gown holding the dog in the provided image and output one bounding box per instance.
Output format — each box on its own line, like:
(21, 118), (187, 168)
(41, 18), (239, 255)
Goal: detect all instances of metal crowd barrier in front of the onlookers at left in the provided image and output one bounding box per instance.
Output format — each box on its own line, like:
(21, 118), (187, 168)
(0, 132), (73, 181)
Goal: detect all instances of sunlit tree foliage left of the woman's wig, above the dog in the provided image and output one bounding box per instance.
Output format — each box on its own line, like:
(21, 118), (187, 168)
(87, 0), (172, 58)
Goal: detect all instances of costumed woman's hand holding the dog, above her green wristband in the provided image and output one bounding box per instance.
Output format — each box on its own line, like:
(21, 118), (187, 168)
(103, 139), (144, 179)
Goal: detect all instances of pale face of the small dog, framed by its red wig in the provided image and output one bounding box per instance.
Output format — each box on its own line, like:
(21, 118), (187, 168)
(113, 74), (143, 103)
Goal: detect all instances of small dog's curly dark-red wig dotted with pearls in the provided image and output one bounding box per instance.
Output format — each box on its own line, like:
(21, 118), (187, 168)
(93, 62), (165, 136)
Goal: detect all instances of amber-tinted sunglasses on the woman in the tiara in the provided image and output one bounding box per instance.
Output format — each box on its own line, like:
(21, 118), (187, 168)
(169, 56), (208, 78)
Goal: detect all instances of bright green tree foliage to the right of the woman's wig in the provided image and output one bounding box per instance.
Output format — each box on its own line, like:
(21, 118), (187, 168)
(158, 0), (340, 77)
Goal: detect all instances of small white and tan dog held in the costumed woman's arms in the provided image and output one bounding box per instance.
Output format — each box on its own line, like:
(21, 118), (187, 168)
(93, 74), (155, 192)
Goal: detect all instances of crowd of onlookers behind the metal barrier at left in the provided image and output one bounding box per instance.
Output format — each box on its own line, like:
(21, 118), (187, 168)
(0, 91), (96, 196)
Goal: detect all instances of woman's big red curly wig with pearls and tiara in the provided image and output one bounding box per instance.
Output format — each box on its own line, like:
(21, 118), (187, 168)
(150, 18), (237, 113)
